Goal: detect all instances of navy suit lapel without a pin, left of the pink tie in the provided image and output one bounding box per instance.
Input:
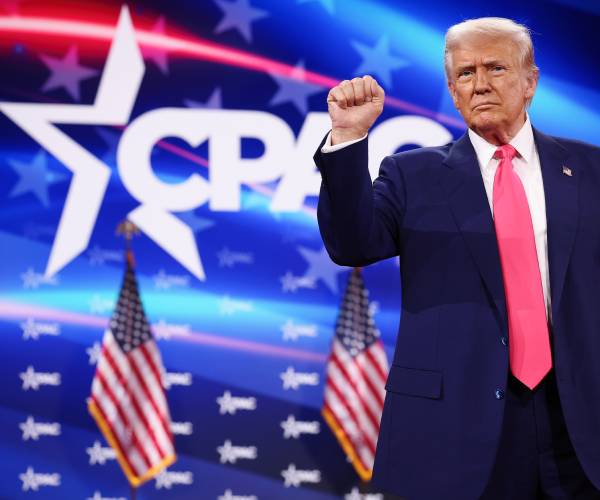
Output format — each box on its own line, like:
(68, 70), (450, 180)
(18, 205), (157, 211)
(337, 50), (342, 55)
(440, 134), (507, 328)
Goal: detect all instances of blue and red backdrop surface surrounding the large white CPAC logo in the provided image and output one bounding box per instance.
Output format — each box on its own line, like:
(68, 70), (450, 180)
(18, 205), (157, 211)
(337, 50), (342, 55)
(0, 0), (600, 500)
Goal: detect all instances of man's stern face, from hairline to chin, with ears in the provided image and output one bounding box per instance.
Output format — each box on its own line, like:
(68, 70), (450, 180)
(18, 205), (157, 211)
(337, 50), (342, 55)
(448, 36), (537, 144)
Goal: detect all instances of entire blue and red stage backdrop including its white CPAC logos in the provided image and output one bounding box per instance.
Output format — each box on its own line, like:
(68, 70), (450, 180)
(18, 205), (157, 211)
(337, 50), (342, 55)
(0, 0), (600, 500)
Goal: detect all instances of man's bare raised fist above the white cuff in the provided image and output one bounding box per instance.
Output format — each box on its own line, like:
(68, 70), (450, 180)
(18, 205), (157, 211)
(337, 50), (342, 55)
(327, 75), (385, 145)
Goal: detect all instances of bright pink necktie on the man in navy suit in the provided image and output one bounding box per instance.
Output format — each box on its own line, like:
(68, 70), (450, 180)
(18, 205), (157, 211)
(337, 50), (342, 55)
(494, 144), (552, 389)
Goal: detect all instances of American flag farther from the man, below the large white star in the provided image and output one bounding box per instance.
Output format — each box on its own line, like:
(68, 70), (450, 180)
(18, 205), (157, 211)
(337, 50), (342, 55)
(88, 251), (175, 486)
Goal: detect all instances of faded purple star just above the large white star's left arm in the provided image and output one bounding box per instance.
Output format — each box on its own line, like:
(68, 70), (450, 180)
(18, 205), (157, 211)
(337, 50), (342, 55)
(40, 45), (98, 101)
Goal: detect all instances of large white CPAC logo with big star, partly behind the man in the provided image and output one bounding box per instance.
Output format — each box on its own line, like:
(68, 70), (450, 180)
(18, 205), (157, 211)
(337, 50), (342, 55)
(0, 7), (452, 280)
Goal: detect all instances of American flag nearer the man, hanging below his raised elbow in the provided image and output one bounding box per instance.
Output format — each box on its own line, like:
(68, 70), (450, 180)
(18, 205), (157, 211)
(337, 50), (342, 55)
(322, 269), (388, 481)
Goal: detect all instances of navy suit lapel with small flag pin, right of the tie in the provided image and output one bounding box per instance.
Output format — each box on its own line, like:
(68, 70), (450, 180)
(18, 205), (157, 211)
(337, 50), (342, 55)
(533, 129), (580, 318)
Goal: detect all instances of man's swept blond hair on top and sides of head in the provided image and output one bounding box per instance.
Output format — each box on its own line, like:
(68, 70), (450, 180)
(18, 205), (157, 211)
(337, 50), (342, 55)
(444, 17), (539, 81)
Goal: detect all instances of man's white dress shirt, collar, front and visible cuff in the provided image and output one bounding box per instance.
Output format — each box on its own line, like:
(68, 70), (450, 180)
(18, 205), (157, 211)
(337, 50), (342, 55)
(321, 117), (551, 317)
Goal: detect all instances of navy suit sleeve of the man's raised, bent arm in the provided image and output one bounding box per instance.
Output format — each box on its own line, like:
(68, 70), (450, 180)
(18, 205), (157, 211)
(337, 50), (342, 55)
(314, 133), (406, 266)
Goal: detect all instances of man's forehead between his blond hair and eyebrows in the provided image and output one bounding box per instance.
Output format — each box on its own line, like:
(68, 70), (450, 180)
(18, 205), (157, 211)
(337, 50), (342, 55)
(450, 35), (519, 68)
